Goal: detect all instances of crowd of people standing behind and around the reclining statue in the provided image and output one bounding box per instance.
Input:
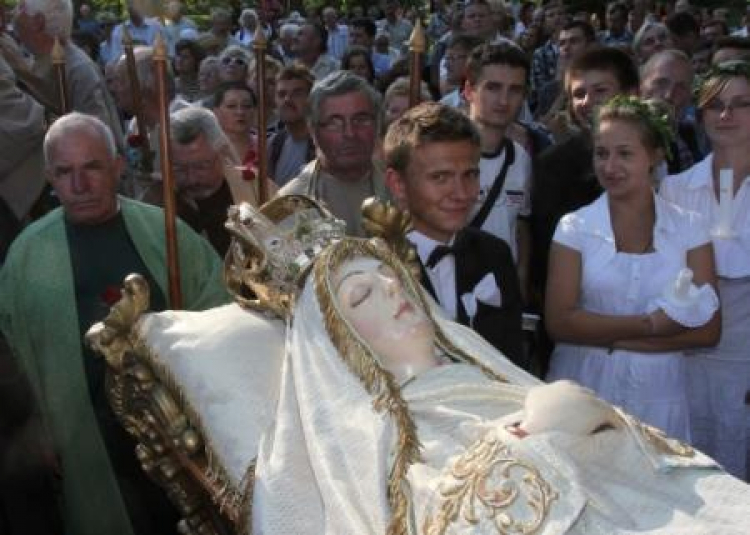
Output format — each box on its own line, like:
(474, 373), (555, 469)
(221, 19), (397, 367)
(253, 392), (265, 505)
(0, 0), (750, 535)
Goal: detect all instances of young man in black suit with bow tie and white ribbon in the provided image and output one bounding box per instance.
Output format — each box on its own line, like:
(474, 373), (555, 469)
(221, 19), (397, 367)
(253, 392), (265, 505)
(384, 102), (528, 368)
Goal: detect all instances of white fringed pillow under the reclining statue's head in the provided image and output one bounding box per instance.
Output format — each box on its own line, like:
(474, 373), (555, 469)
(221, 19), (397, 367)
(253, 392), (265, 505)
(137, 304), (285, 489)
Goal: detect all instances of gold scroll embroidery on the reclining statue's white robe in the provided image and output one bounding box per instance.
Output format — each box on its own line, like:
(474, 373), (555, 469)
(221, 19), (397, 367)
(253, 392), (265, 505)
(422, 433), (558, 535)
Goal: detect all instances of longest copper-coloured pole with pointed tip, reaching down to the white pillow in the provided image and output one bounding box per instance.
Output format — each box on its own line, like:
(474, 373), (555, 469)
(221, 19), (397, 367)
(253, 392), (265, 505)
(153, 34), (182, 310)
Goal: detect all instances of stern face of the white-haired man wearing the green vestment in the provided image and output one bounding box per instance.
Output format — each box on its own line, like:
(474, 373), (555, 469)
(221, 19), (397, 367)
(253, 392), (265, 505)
(47, 128), (124, 225)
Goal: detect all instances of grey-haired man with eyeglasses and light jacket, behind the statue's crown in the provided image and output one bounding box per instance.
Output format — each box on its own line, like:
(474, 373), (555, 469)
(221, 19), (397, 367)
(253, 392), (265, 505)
(279, 71), (389, 237)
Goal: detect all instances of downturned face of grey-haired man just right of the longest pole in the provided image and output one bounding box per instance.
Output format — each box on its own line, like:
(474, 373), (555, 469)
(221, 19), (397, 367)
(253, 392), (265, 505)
(172, 134), (224, 199)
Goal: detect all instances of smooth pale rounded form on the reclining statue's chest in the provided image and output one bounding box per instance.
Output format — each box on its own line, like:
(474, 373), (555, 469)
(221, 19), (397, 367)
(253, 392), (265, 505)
(521, 381), (617, 435)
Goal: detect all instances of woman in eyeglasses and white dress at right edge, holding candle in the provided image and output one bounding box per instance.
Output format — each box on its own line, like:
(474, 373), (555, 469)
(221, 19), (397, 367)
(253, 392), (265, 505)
(660, 61), (750, 481)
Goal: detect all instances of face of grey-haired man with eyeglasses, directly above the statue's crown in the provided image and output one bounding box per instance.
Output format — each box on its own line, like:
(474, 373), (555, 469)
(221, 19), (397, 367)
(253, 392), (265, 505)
(313, 91), (377, 174)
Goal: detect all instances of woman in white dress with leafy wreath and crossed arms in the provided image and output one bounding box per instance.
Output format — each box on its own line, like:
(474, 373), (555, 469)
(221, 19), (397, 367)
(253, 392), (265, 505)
(545, 97), (721, 441)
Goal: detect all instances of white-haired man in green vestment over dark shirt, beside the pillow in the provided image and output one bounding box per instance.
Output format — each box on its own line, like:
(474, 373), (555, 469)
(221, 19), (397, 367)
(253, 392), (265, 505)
(0, 113), (229, 535)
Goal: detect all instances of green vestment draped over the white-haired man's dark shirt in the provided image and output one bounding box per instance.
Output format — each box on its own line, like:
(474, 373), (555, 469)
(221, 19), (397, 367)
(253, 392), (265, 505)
(0, 199), (229, 535)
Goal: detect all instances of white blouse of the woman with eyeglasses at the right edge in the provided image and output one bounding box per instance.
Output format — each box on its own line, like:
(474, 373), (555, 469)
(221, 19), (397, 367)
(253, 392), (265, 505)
(659, 154), (750, 279)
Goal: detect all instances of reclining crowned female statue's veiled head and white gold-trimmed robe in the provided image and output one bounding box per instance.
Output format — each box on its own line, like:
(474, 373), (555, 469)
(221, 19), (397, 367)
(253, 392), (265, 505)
(252, 239), (750, 535)
